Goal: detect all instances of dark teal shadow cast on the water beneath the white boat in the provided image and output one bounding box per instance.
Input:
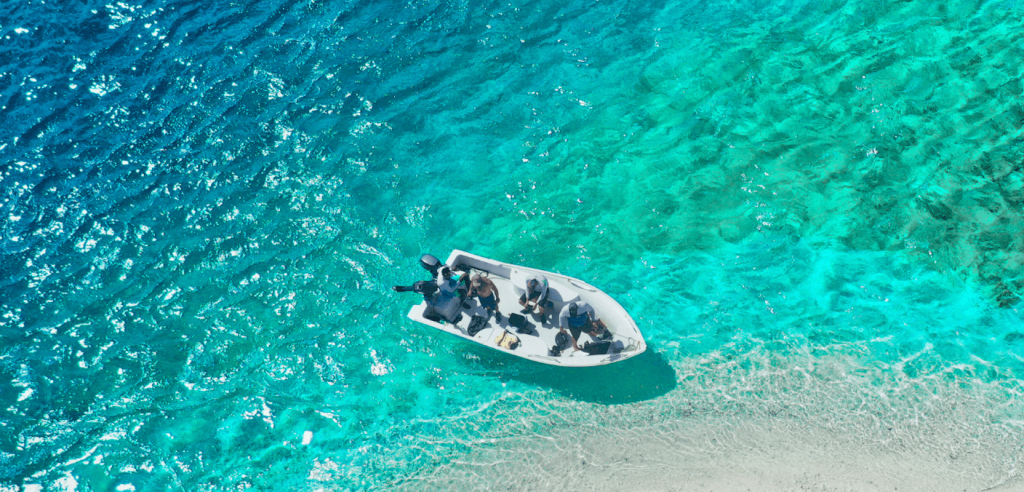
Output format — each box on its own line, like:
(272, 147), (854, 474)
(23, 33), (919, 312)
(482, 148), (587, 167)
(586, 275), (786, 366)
(468, 345), (676, 405)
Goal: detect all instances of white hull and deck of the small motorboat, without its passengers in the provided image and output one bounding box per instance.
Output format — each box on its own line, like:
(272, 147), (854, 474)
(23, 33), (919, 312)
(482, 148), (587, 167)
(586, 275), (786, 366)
(409, 250), (647, 367)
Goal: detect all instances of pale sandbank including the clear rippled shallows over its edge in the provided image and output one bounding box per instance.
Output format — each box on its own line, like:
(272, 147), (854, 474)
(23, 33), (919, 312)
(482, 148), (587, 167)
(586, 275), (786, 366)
(392, 356), (1024, 492)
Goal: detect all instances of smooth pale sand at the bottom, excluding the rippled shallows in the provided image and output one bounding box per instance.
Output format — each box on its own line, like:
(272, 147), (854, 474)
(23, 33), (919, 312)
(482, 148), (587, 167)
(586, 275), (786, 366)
(406, 420), (1024, 492)
